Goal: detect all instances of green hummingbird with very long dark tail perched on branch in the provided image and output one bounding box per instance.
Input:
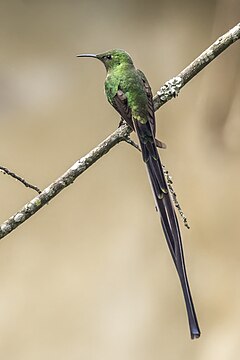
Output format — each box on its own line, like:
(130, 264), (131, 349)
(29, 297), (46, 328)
(77, 49), (200, 339)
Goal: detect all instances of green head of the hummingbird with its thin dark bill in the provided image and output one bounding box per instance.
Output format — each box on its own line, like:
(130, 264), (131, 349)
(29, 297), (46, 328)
(77, 49), (133, 71)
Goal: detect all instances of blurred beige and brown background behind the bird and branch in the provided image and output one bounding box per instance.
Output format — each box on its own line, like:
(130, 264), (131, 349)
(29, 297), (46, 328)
(0, 0), (240, 360)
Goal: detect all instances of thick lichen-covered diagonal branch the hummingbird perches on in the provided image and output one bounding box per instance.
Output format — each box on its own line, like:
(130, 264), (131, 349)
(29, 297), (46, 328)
(0, 23), (240, 239)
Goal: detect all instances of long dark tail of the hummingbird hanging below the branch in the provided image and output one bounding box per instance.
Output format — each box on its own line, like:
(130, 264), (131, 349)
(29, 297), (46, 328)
(134, 120), (201, 339)
